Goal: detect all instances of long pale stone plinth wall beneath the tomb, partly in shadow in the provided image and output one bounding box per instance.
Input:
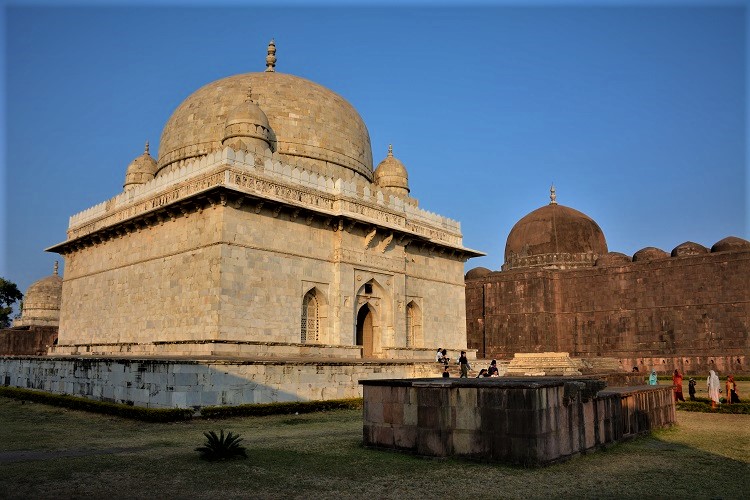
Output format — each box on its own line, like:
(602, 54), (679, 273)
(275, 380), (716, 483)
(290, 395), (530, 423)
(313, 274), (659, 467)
(0, 356), (440, 408)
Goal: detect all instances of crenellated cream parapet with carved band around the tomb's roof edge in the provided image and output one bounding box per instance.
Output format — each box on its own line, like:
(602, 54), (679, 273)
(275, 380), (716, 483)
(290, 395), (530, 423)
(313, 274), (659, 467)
(52, 147), (484, 254)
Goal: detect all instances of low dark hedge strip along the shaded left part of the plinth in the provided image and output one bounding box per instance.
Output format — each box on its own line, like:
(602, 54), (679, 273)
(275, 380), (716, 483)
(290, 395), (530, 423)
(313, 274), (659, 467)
(0, 386), (193, 422)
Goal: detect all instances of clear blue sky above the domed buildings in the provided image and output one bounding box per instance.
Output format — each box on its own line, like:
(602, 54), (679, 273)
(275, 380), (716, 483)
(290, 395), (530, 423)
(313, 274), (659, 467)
(0, 1), (750, 291)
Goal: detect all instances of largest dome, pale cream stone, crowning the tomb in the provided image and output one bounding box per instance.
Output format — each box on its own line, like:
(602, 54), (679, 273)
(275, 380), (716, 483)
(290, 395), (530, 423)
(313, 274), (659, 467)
(156, 71), (372, 181)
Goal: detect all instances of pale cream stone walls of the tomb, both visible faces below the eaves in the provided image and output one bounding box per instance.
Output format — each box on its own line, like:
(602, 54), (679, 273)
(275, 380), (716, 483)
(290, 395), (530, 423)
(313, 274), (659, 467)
(55, 178), (466, 358)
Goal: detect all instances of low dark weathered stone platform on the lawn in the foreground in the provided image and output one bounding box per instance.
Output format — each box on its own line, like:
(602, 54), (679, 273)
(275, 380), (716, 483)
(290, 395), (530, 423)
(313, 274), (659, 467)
(360, 377), (675, 465)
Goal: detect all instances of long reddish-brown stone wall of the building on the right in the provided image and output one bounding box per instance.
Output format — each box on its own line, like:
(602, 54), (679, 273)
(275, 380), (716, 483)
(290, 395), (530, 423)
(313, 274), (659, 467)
(466, 252), (750, 373)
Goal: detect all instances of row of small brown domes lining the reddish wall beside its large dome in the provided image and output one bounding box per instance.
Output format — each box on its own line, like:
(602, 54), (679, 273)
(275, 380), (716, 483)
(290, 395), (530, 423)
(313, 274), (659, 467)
(465, 236), (750, 279)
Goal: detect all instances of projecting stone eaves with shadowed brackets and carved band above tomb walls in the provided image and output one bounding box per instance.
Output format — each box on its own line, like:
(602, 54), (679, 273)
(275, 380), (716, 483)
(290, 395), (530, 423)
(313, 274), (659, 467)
(46, 163), (485, 260)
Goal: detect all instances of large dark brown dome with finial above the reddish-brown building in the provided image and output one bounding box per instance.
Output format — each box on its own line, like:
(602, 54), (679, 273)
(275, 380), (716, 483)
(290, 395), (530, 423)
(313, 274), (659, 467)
(503, 191), (607, 271)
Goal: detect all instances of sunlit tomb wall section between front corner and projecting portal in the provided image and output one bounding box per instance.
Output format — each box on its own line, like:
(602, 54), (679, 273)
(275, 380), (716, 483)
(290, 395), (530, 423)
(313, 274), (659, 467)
(217, 206), (338, 344)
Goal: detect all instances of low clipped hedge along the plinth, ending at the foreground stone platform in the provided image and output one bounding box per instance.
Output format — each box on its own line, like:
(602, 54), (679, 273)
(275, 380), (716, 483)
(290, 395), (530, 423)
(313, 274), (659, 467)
(200, 398), (362, 418)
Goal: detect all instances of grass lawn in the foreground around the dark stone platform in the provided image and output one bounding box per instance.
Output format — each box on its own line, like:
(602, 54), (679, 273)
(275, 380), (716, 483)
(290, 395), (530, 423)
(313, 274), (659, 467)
(0, 397), (750, 499)
